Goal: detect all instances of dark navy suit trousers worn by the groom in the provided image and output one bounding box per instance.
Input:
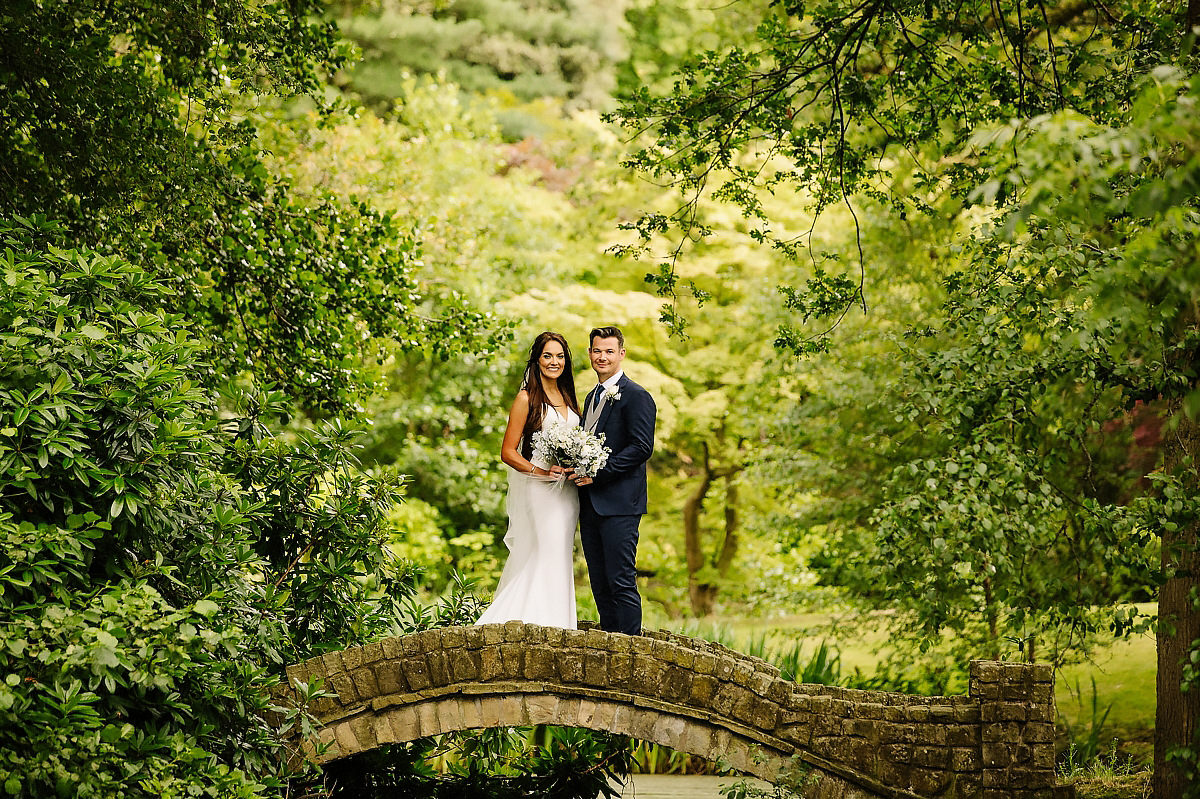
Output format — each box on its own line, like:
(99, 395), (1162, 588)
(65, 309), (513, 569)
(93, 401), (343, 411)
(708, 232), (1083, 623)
(580, 497), (642, 636)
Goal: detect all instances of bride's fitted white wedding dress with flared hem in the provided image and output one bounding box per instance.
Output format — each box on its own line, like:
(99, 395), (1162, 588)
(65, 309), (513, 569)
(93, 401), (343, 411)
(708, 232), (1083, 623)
(475, 405), (580, 630)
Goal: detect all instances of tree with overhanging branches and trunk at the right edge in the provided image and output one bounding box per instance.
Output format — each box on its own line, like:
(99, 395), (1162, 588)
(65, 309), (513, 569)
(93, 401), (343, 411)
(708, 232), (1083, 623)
(618, 2), (1200, 797)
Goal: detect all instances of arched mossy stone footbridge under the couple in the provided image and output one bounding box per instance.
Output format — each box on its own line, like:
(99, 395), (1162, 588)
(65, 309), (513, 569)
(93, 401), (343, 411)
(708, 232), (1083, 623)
(281, 621), (1057, 799)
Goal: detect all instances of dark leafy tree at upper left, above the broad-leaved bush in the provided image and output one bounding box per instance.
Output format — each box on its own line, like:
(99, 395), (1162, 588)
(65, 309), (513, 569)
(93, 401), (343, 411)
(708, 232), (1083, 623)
(0, 0), (494, 416)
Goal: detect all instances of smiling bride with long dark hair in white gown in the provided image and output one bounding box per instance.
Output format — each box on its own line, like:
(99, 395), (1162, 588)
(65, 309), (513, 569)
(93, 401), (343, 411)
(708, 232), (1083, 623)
(476, 332), (580, 630)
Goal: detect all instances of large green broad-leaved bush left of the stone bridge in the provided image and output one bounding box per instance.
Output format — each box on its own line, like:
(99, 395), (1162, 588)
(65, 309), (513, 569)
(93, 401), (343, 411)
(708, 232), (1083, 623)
(0, 218), (429, 799)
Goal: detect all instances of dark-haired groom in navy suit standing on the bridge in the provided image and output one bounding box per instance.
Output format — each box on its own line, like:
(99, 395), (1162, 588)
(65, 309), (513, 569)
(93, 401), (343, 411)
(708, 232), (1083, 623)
(572, 326), (656, 636)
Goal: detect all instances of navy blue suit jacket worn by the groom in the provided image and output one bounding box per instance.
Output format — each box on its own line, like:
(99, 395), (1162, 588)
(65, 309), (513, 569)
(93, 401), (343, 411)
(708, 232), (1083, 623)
(580, 374), (658, 516)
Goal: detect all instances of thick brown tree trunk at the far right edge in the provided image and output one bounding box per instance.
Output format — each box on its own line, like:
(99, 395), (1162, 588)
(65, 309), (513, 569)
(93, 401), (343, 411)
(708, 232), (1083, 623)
(1152, 403), (1200, 799)
